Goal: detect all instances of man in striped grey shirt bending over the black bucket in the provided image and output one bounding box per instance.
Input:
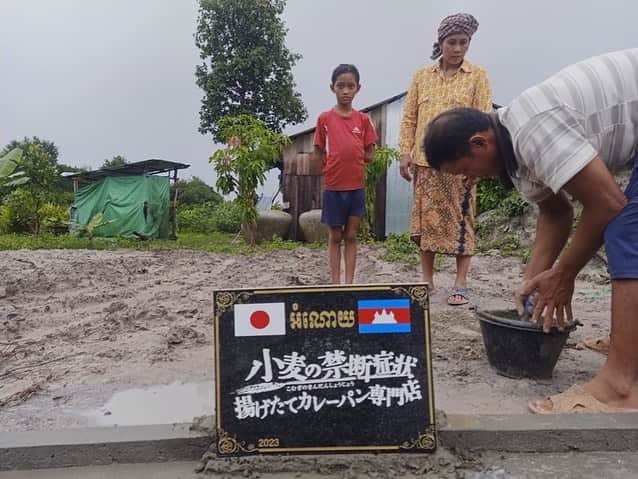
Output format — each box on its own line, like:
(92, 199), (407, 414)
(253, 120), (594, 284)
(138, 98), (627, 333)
(424, 49), (638, 413)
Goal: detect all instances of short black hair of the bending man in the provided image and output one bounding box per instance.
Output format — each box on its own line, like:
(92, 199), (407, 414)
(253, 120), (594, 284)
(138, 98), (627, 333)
(423, 108), (490, 170)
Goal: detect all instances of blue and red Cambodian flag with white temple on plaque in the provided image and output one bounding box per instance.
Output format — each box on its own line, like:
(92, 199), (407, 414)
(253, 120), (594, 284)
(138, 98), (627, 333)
(358, 299), (410, 334)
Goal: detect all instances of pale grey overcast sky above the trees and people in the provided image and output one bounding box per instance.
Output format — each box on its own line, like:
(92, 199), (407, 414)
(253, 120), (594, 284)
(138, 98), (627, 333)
(0, 0), (638, 193)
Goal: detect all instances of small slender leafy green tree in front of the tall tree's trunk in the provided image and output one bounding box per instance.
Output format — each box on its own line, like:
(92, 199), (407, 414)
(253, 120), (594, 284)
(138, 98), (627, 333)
(210, 115), (290, 245)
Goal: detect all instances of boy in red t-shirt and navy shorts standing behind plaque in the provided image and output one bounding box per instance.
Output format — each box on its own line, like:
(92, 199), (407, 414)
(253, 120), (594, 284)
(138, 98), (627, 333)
(314, 64), (377, 284)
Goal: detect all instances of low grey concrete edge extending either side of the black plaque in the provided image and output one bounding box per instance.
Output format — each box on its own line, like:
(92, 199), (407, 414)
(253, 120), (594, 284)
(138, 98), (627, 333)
(0, 414), (638, 470)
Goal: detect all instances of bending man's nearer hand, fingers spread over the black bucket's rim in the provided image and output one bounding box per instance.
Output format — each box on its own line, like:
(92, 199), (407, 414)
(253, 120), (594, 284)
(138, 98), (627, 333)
(516, 265), (576, 333)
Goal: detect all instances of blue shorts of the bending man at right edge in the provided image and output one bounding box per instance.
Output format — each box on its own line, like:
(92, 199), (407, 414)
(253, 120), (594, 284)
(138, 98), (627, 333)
(605, 156), (638, 279)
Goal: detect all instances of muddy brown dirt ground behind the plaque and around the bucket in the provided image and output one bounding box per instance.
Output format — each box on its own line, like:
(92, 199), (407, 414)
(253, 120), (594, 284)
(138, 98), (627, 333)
(0, 246), (610, 431)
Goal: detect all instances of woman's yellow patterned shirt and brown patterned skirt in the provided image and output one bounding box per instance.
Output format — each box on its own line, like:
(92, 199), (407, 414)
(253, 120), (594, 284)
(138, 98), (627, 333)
(399, 60), (492, 255)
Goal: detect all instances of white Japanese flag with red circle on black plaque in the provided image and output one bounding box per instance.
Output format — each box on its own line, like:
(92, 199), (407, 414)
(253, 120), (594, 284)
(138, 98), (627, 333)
(234, 303), (286, 336)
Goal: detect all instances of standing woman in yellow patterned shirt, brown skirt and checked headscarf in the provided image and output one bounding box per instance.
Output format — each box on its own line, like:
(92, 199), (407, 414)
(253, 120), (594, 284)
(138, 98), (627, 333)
(399, 13), (492, 305)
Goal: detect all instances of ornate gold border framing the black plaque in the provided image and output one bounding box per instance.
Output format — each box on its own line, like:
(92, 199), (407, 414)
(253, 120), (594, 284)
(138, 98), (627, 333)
(213, 283), (436, 455)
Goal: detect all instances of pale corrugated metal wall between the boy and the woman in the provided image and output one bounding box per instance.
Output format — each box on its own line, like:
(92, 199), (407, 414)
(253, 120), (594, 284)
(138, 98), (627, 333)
(385, 97), (412, 235)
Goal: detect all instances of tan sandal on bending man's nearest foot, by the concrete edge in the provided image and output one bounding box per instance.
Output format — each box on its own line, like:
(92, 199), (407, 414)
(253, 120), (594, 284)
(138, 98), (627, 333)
(527, 384), (638, 414)
